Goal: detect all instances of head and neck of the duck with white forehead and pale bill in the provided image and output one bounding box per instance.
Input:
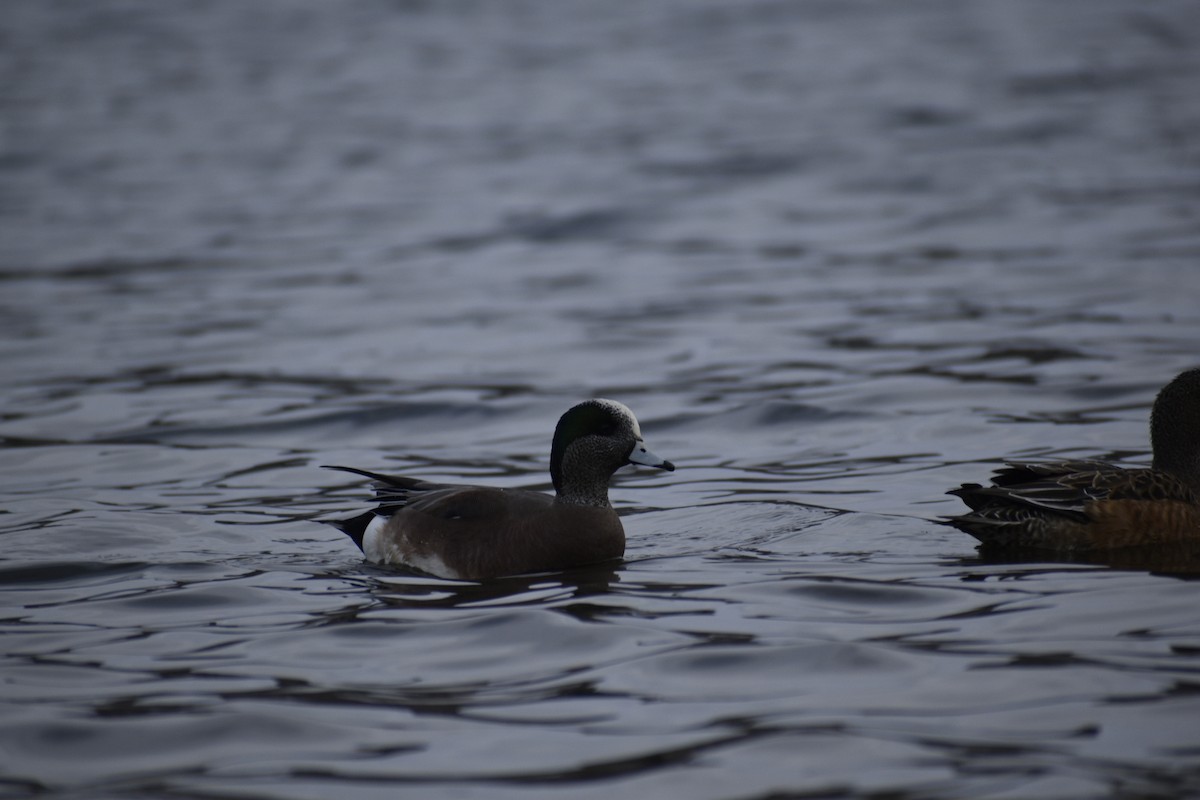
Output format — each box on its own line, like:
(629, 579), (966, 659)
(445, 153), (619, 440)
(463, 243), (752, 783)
(550, 399), (674, 505)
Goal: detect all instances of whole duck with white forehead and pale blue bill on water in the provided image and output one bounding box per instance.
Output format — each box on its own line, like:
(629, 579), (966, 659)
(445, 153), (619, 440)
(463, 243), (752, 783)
(326, 398), (676, 581)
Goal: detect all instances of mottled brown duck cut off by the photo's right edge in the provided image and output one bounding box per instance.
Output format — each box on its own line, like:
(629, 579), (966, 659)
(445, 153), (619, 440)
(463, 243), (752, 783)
(946, 368), (1200, 553)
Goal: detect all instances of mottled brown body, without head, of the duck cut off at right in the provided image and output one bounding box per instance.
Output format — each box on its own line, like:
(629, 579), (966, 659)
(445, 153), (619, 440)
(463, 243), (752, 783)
(947, 462), (1200, 553)
